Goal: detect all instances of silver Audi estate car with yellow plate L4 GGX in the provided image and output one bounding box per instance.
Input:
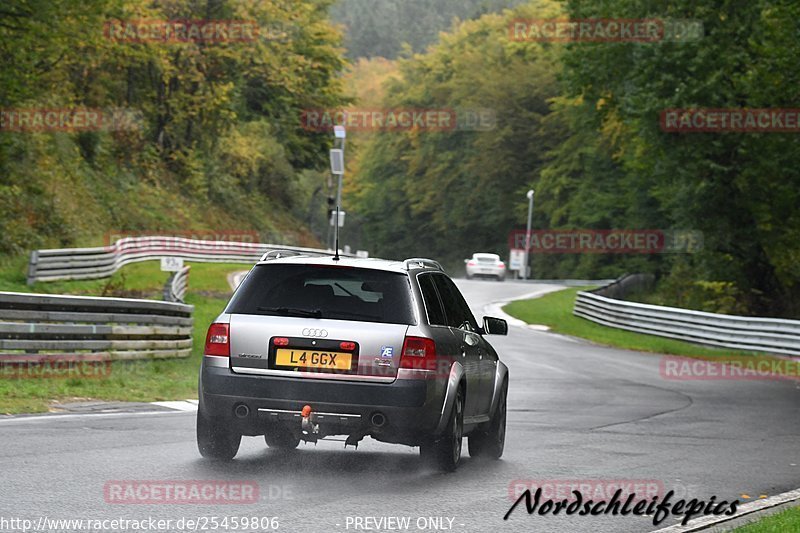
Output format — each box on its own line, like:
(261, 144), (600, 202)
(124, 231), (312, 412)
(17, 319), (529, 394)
(197, 252), (508, 471)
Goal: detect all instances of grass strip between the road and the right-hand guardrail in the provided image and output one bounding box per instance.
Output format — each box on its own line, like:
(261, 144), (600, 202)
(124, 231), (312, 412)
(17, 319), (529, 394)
(503, 287), (764, 358)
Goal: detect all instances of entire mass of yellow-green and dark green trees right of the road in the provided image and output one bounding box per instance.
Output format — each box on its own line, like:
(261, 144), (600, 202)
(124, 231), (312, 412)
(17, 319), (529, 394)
(357, 0), (800, 316)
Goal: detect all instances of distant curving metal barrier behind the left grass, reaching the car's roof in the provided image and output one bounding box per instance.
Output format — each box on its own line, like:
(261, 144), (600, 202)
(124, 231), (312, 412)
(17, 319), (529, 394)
(28, 236), (349, 285)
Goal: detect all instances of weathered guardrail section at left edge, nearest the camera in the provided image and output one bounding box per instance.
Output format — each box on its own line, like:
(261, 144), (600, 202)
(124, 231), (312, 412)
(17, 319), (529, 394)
(0, 292), (194, 363)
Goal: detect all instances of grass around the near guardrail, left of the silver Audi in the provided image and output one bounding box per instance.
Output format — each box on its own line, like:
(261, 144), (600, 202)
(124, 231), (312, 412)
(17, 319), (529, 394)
(0, 261), (251, 414)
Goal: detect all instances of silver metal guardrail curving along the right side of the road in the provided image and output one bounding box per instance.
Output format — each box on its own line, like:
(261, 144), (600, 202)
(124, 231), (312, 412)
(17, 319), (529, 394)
(573, 278), (800, 355)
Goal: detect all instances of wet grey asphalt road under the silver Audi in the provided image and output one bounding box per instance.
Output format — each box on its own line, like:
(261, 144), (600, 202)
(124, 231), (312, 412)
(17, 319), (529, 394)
(0, 281), (800, 532)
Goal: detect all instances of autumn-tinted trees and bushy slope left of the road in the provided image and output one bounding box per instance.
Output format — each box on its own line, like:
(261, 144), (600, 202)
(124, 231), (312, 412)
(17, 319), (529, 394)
(0, 0), (347, 254)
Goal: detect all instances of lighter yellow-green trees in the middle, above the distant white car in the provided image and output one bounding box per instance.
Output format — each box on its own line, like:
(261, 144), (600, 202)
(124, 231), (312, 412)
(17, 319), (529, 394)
(351, 2), (559, 261)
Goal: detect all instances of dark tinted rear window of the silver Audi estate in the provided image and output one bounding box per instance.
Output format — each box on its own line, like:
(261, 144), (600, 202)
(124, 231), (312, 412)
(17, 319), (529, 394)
(226, 264), (416, 324)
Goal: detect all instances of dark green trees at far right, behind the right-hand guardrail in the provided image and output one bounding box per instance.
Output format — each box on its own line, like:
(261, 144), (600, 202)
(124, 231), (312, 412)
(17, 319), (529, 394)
(564, 0), (800, 315)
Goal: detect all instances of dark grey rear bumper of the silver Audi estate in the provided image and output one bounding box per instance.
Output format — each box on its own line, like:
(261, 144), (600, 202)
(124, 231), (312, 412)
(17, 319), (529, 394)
(199, 361), (445, 445)
